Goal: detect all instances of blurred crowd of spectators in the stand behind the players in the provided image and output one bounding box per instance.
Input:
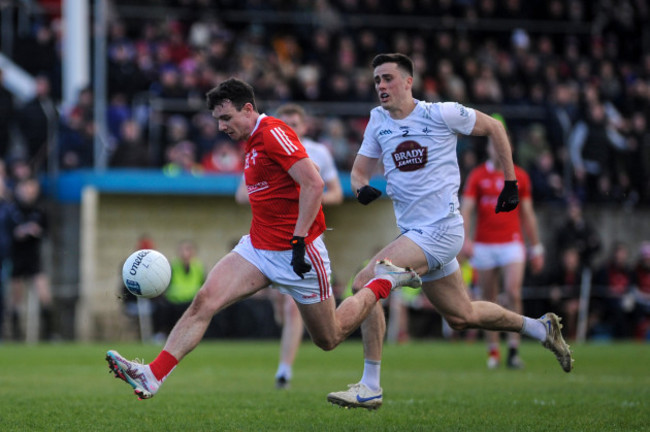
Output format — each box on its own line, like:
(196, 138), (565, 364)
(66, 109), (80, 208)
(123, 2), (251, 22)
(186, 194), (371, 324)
(0, 0), (650, 340)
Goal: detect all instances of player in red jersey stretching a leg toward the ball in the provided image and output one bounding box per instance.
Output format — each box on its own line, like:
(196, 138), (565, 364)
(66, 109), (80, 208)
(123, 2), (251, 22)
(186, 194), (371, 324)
(106, 78), (420, 399)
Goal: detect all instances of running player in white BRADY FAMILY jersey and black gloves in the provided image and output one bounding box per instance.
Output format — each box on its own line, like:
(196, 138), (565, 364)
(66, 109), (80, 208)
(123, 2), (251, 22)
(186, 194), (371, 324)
(327, 54), (573, 408)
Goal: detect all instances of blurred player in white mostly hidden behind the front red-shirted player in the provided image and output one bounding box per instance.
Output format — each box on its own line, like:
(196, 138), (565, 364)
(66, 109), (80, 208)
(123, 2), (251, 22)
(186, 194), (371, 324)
(235, 103), (343, 389)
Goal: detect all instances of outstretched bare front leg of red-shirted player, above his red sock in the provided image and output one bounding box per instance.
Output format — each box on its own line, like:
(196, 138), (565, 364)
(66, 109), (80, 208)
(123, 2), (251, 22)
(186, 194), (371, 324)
(164, 252), (270, 361)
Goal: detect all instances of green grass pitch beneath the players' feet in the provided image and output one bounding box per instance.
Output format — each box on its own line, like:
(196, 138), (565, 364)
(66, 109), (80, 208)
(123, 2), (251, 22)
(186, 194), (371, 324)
(0, 340), (650, 432)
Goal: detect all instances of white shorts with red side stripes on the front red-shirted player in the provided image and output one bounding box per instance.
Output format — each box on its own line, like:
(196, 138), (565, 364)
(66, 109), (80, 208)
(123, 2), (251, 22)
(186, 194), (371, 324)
(233, 235), (332, 304)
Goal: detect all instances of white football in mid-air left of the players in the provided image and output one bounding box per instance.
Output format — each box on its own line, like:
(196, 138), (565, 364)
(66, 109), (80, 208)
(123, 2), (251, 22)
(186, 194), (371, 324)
(122, 249), (172, 298)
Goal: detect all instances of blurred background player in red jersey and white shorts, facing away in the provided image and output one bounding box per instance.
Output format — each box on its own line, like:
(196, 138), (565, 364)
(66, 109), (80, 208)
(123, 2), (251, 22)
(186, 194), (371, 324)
(460, 116), (544, 369)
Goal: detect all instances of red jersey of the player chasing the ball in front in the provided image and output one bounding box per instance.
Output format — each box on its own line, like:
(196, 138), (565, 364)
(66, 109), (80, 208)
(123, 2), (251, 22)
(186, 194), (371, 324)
(244, 114), (325, 250)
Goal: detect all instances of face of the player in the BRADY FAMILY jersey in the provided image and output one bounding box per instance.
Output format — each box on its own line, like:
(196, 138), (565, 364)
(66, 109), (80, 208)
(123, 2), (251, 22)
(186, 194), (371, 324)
(374, 63), (413, 111)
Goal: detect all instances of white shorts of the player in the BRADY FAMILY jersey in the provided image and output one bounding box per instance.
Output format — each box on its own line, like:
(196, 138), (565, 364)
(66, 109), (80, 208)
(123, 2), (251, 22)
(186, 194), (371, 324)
(402, 218), (465, 282)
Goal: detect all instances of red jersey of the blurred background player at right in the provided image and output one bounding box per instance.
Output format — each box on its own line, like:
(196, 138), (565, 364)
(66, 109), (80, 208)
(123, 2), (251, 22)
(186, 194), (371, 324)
(463, 161), (532, 243)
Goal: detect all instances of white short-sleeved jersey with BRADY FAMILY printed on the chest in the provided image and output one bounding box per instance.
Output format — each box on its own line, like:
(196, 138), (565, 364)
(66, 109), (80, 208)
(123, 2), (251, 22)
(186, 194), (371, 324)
(359, 100), (476, 231)
